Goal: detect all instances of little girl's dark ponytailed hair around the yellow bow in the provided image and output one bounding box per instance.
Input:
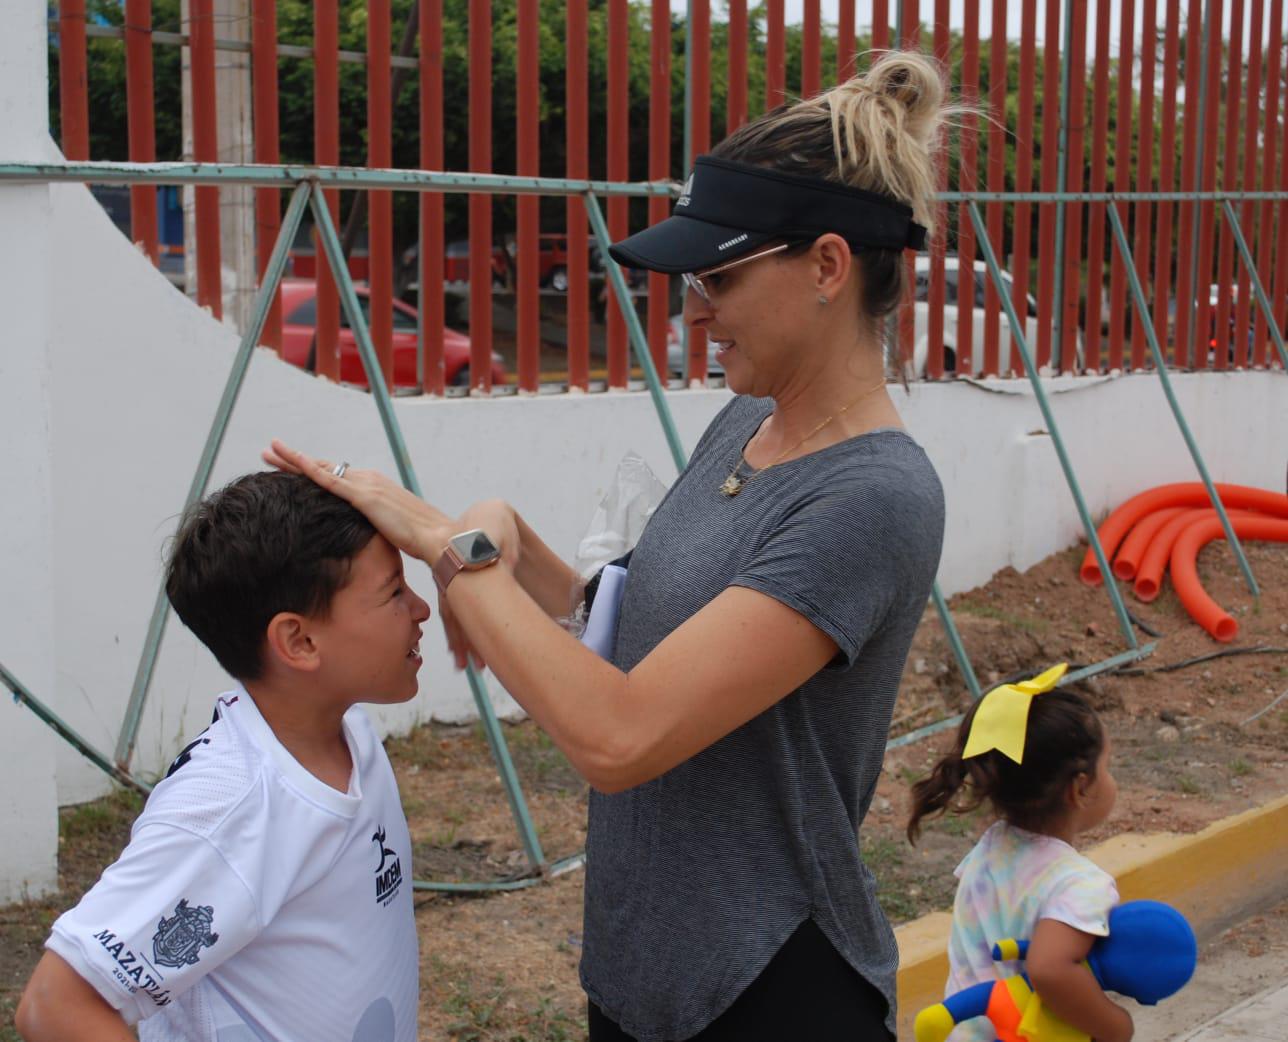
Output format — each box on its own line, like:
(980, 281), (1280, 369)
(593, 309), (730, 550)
(908, 690), (1105, 842)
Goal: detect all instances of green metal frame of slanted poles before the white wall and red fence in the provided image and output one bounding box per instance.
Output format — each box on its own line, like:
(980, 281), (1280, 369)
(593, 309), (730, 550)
(0, 162), (1288, 891)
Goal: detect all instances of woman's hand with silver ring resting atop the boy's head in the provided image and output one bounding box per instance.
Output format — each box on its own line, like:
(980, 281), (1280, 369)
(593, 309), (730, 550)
(263, 438), (452, 563)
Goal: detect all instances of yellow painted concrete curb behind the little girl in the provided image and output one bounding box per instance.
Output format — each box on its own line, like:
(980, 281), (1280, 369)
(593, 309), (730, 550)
(894, 796), (1288, 1038)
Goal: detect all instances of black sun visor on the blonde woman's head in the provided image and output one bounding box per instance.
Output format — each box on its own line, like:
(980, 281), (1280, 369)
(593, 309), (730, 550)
(608, 156), (926, 274)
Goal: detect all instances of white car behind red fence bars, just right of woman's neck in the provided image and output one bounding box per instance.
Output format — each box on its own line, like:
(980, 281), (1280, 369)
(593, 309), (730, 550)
(912, 254), (1083, 377)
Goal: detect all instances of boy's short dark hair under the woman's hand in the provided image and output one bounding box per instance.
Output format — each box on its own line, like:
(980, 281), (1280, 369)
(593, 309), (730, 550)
(165, 471), (376, 680)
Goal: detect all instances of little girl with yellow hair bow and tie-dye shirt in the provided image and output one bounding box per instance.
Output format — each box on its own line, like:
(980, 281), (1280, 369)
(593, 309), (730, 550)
(908, 666), (1133, 1042)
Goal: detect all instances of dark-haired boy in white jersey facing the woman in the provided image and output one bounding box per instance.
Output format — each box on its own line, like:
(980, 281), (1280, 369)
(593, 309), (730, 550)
(17, 473), (429, 1042)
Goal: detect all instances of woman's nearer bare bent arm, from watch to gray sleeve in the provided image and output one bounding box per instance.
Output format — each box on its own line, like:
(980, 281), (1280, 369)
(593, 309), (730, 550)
(446, 556), (837, 792)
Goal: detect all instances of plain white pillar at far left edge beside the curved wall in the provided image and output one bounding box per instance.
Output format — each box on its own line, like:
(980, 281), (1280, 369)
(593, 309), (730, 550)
(0, 0), (58, 903)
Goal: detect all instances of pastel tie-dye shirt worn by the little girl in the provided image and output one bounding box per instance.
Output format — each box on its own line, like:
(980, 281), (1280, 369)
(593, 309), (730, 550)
(944, 822), (1118, 1042)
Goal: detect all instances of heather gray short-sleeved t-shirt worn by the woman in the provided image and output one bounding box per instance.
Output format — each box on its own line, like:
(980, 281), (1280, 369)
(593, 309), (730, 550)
(581, 397), (944, 1042)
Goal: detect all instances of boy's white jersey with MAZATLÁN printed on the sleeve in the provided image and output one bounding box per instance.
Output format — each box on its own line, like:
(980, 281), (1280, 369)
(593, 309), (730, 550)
(46, 689), (420, 1042)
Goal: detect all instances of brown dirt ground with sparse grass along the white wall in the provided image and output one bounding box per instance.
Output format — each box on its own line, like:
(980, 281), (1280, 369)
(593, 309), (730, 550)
(0, 544), (1288, 1042)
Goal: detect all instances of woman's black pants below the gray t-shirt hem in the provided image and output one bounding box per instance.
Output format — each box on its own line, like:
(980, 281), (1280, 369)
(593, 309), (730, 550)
(587, 920), (894, 1042)
